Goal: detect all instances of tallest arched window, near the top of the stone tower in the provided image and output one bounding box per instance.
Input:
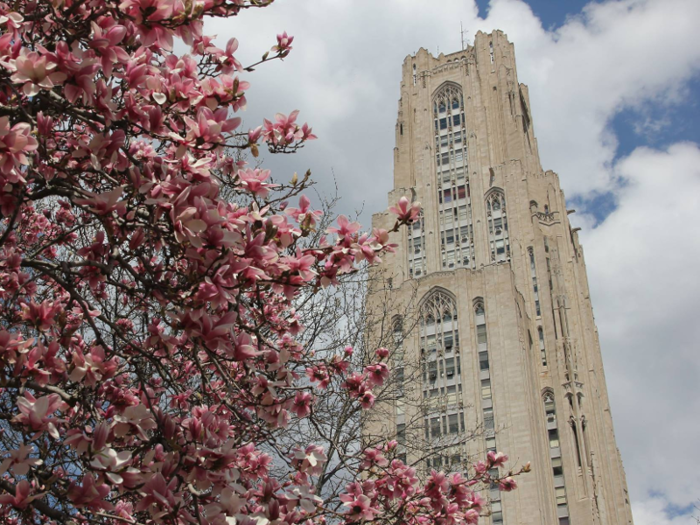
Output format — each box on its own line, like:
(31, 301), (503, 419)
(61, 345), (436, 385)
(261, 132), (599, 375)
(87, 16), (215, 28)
(433, 82), (476, 270)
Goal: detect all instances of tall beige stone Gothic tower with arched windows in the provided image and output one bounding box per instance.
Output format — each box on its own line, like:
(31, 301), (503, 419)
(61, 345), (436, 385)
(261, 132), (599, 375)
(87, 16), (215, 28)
(365, 31), (632, 525)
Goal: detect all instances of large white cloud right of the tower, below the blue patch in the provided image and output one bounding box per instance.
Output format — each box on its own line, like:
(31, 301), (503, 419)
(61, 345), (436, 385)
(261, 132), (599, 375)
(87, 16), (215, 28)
(582, 143), (700, 506)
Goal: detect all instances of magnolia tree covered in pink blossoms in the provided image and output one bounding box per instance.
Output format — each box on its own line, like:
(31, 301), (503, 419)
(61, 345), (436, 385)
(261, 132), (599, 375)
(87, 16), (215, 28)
(0, 0), (515, 525)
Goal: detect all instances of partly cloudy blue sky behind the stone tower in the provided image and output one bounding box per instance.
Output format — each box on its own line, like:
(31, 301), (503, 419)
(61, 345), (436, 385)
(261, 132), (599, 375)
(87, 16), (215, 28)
(205, 0), (700, 525)
